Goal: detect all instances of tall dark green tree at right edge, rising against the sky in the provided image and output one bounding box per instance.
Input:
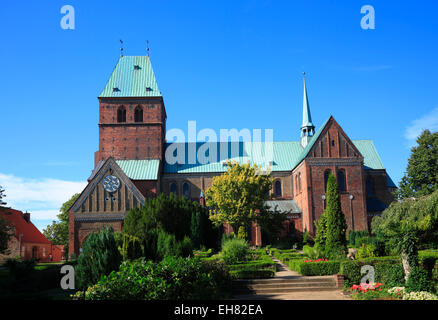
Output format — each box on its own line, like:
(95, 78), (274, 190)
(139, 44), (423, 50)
(396, 130), (438, 199)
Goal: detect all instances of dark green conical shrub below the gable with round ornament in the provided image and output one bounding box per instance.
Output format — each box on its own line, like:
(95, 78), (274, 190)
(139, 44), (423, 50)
(75, 227), (122, 289)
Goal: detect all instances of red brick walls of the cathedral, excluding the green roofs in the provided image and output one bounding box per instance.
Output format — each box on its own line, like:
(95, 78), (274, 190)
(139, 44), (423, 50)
(69, 57), (393, 254)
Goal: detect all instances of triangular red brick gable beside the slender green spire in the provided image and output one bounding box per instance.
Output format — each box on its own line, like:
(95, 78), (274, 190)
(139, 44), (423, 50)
(307, 116), (363, 158)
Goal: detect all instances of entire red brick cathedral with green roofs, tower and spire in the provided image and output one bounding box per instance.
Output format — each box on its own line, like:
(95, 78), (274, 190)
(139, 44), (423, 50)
(69, 55), (396, 255)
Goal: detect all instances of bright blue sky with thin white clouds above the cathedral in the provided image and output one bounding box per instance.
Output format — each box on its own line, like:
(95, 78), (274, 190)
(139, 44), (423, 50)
(0, 0), (438, 229)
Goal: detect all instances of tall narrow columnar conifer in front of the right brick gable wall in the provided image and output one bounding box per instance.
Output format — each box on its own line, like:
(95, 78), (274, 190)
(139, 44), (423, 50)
(324, 173), (347, 259)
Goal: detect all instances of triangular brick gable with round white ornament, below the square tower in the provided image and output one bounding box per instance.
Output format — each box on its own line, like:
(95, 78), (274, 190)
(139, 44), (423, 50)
(70, 158), (145, 213)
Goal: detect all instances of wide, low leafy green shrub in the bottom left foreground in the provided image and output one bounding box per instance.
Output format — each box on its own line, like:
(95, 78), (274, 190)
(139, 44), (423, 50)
(77, 257), (229, 300)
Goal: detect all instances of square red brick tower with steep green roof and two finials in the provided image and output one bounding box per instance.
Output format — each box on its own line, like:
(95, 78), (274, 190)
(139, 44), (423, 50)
(94, 54), (166, 167)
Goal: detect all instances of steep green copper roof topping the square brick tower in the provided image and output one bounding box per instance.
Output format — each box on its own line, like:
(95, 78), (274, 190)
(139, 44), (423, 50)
(99, 56), (161, 98)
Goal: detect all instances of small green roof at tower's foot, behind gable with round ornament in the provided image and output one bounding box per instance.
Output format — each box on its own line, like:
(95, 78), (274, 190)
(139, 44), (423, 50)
(116, 159), (160, 180)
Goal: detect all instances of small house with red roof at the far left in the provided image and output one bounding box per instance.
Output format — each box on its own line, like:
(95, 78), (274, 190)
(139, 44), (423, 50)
(0, 207), (64, 264)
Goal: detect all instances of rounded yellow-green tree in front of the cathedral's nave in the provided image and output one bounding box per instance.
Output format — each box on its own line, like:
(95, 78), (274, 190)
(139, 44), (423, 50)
(205, 161), (272, 238)
